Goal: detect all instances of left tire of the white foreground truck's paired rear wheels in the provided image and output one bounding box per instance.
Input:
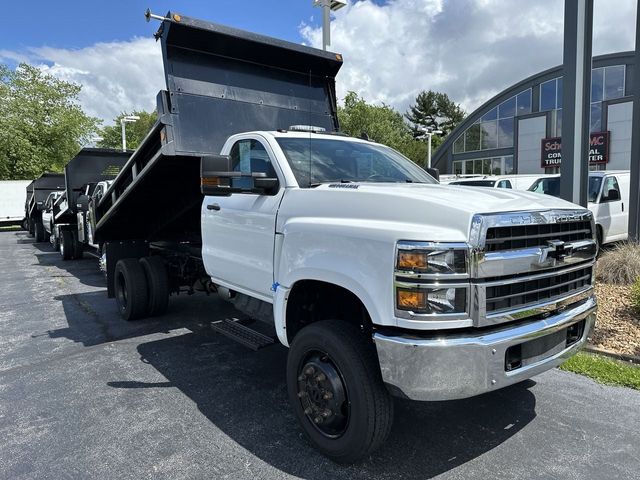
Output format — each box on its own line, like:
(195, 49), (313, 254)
(114, 258), (149, 321)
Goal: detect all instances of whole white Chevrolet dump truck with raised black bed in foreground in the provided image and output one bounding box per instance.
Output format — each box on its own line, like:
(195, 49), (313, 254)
(95, 13), (596, 462)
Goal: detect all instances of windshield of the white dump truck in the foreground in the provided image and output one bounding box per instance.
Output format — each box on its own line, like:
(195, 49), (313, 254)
(277, 137), (438, 188)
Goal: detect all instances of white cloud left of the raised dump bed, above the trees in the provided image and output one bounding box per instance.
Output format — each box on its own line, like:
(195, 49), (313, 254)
(0, 38), (166, 124)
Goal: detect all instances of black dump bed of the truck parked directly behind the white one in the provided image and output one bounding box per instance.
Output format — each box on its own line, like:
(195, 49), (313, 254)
(64, 148), (131, 214)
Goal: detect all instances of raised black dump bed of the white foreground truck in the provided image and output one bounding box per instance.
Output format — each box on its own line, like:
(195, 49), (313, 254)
(96, 12), (342, 242)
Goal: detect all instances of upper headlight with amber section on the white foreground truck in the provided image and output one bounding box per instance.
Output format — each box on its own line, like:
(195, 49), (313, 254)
(396, 242), (467, 276)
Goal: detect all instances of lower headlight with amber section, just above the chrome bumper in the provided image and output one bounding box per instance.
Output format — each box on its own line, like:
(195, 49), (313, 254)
(396, 285), (467, 315)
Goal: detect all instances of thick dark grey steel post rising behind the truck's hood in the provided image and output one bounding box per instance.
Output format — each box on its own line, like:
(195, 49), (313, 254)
(560, 0), (593, 207)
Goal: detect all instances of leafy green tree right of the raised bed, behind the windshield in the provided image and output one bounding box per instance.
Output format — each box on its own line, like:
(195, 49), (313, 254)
(338, 92), (427, 165)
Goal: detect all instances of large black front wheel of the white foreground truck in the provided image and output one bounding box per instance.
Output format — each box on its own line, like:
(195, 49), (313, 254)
(287, 320), (393, 463)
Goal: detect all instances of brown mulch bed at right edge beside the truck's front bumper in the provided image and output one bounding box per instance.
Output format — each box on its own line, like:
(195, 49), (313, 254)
(591, 283), (640, 356)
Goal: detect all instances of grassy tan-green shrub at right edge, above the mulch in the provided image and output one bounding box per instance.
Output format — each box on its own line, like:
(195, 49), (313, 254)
(596, 242), (640, 285)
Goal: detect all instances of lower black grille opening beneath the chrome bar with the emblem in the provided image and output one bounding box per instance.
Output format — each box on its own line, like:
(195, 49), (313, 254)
(486, 266), (593, 313)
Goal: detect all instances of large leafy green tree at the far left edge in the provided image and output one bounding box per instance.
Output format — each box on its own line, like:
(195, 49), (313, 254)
(0, 63), (100, 180)
